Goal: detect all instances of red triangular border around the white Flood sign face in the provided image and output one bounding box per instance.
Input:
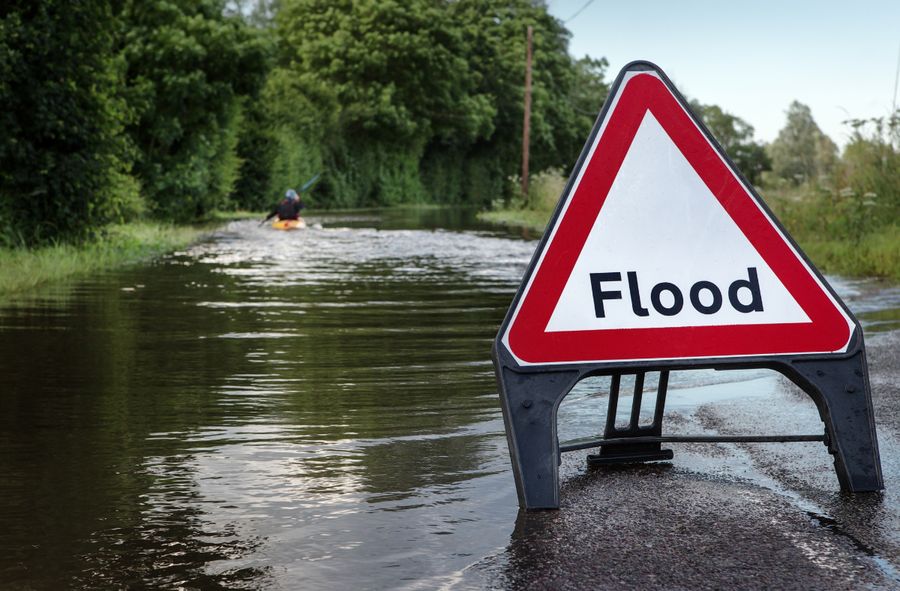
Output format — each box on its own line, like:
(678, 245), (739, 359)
(506, 73), (852, 364)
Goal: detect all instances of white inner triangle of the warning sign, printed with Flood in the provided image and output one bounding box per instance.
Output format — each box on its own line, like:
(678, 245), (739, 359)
(546, 111), (810, 332)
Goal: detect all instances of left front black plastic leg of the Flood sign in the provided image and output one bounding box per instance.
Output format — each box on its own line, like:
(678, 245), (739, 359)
(497, 367), (579, 510)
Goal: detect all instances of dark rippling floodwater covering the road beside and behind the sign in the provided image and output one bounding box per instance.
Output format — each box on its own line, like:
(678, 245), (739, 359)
(0, 210), (900, 589)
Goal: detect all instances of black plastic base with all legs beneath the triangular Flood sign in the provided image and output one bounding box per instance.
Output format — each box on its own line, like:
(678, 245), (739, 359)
(493, 340), (884, 510)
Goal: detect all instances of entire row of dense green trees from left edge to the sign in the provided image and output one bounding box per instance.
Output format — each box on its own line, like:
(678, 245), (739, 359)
(0, 0), (608, 245)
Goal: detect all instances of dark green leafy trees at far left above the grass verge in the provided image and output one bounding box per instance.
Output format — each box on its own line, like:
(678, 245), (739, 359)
(0, 0), (269, 245)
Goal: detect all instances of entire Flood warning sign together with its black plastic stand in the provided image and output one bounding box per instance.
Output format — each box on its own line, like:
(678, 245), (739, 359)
(493, 62), (883, 509)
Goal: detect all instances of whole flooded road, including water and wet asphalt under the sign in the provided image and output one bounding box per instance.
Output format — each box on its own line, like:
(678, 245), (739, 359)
(0, 210), (900, 589)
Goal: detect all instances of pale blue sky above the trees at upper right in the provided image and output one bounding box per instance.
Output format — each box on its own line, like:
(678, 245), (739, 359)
(547, 0), (900, 146)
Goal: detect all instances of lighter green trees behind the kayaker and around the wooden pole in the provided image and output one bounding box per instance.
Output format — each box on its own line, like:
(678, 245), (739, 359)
(256, 0), (605, 206)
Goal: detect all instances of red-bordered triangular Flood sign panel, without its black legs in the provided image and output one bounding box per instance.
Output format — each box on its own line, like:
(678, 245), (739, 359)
(501, 62), (855, 365)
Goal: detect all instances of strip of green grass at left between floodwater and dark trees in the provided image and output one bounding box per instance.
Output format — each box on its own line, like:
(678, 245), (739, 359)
(0, 222), (210, 297)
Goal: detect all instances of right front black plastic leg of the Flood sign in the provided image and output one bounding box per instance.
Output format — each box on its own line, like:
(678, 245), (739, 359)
(790, 350), (884, 492)
